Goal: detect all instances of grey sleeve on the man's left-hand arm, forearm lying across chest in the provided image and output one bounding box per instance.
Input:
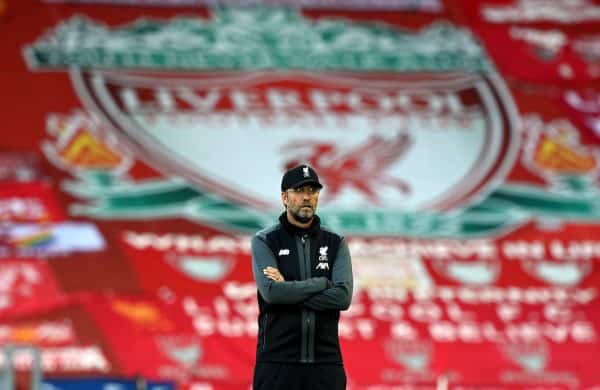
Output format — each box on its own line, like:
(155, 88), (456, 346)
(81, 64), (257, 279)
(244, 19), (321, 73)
(252, 236), (328, 304)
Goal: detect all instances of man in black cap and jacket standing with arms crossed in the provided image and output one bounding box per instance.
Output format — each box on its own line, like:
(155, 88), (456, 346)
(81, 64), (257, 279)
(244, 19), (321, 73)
(252, 165), (353, 390)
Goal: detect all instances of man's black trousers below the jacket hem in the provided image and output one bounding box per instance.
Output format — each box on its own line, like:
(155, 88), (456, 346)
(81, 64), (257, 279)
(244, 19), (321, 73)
(252, 362), (346, 390)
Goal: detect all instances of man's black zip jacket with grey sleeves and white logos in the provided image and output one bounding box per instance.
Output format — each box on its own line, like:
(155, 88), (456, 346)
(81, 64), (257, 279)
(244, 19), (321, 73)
(252, 213), (353, 364)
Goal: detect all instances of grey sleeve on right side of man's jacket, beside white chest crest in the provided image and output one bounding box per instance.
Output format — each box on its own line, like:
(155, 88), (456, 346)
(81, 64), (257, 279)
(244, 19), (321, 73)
(304, 239), (354, 310)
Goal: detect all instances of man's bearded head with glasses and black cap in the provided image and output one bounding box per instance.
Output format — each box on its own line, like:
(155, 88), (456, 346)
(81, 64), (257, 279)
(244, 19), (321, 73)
(281, 165), (323, 226)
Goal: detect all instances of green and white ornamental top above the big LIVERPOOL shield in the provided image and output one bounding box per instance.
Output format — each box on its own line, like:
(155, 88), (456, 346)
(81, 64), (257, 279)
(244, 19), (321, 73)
(25, 7), (492, 72)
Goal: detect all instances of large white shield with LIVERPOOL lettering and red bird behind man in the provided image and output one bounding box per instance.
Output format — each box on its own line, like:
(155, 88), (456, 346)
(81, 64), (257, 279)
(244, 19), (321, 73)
(67, 66), (518, 235)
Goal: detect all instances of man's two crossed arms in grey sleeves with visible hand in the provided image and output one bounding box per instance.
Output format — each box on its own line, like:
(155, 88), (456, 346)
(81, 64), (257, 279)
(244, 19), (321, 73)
(252, 236), (353, 310)
